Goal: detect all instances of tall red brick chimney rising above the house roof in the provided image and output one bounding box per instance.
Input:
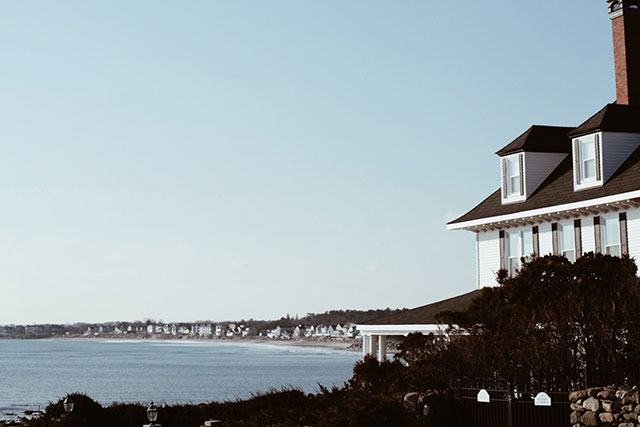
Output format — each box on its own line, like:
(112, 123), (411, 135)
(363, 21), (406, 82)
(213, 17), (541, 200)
(607, 0), (640, 105)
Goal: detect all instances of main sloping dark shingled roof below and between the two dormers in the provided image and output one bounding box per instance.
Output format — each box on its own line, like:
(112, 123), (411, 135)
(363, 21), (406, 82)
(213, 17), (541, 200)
(449, 148), (640, 224)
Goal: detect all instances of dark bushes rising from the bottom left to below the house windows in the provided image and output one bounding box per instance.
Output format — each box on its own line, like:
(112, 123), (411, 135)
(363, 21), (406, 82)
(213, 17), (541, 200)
(26, 254), (640, 427)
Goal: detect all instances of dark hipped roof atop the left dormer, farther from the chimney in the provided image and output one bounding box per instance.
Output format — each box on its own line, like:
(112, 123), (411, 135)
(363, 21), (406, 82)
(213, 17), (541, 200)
(496, 125), (575, 156)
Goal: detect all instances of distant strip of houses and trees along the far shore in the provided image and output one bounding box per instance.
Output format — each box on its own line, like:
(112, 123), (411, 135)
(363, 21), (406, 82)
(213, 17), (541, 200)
(0, 309), (410, 341)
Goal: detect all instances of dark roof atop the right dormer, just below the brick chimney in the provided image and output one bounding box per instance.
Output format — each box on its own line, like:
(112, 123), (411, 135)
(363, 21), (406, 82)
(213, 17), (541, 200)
(569, 104), (640, 137)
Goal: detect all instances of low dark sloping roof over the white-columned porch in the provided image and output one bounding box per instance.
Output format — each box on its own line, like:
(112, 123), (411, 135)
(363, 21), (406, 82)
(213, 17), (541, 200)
(361, 289), (482, 325)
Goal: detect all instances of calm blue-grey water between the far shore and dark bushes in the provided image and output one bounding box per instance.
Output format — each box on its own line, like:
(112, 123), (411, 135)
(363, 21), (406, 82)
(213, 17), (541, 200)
(0, 340), (358, 419)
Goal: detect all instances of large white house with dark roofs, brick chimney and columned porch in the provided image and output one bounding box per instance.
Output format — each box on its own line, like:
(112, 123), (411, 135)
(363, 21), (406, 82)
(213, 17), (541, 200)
(358, 0), (640, 359)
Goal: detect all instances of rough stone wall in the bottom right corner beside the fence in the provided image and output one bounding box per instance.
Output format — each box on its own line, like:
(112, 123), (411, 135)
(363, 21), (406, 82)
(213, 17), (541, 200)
(569, 387), (640, 427)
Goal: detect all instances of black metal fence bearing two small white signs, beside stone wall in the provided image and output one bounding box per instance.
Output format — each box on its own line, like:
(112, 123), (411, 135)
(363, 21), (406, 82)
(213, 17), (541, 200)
(452, 382), (571, 427)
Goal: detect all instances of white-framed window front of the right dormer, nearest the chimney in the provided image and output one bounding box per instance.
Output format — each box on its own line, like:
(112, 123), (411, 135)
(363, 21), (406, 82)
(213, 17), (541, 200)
(573, 133), (602, 190)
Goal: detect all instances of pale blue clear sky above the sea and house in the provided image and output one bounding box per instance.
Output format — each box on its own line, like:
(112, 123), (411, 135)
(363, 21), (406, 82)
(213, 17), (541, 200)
(0, 0), (615, 323)
